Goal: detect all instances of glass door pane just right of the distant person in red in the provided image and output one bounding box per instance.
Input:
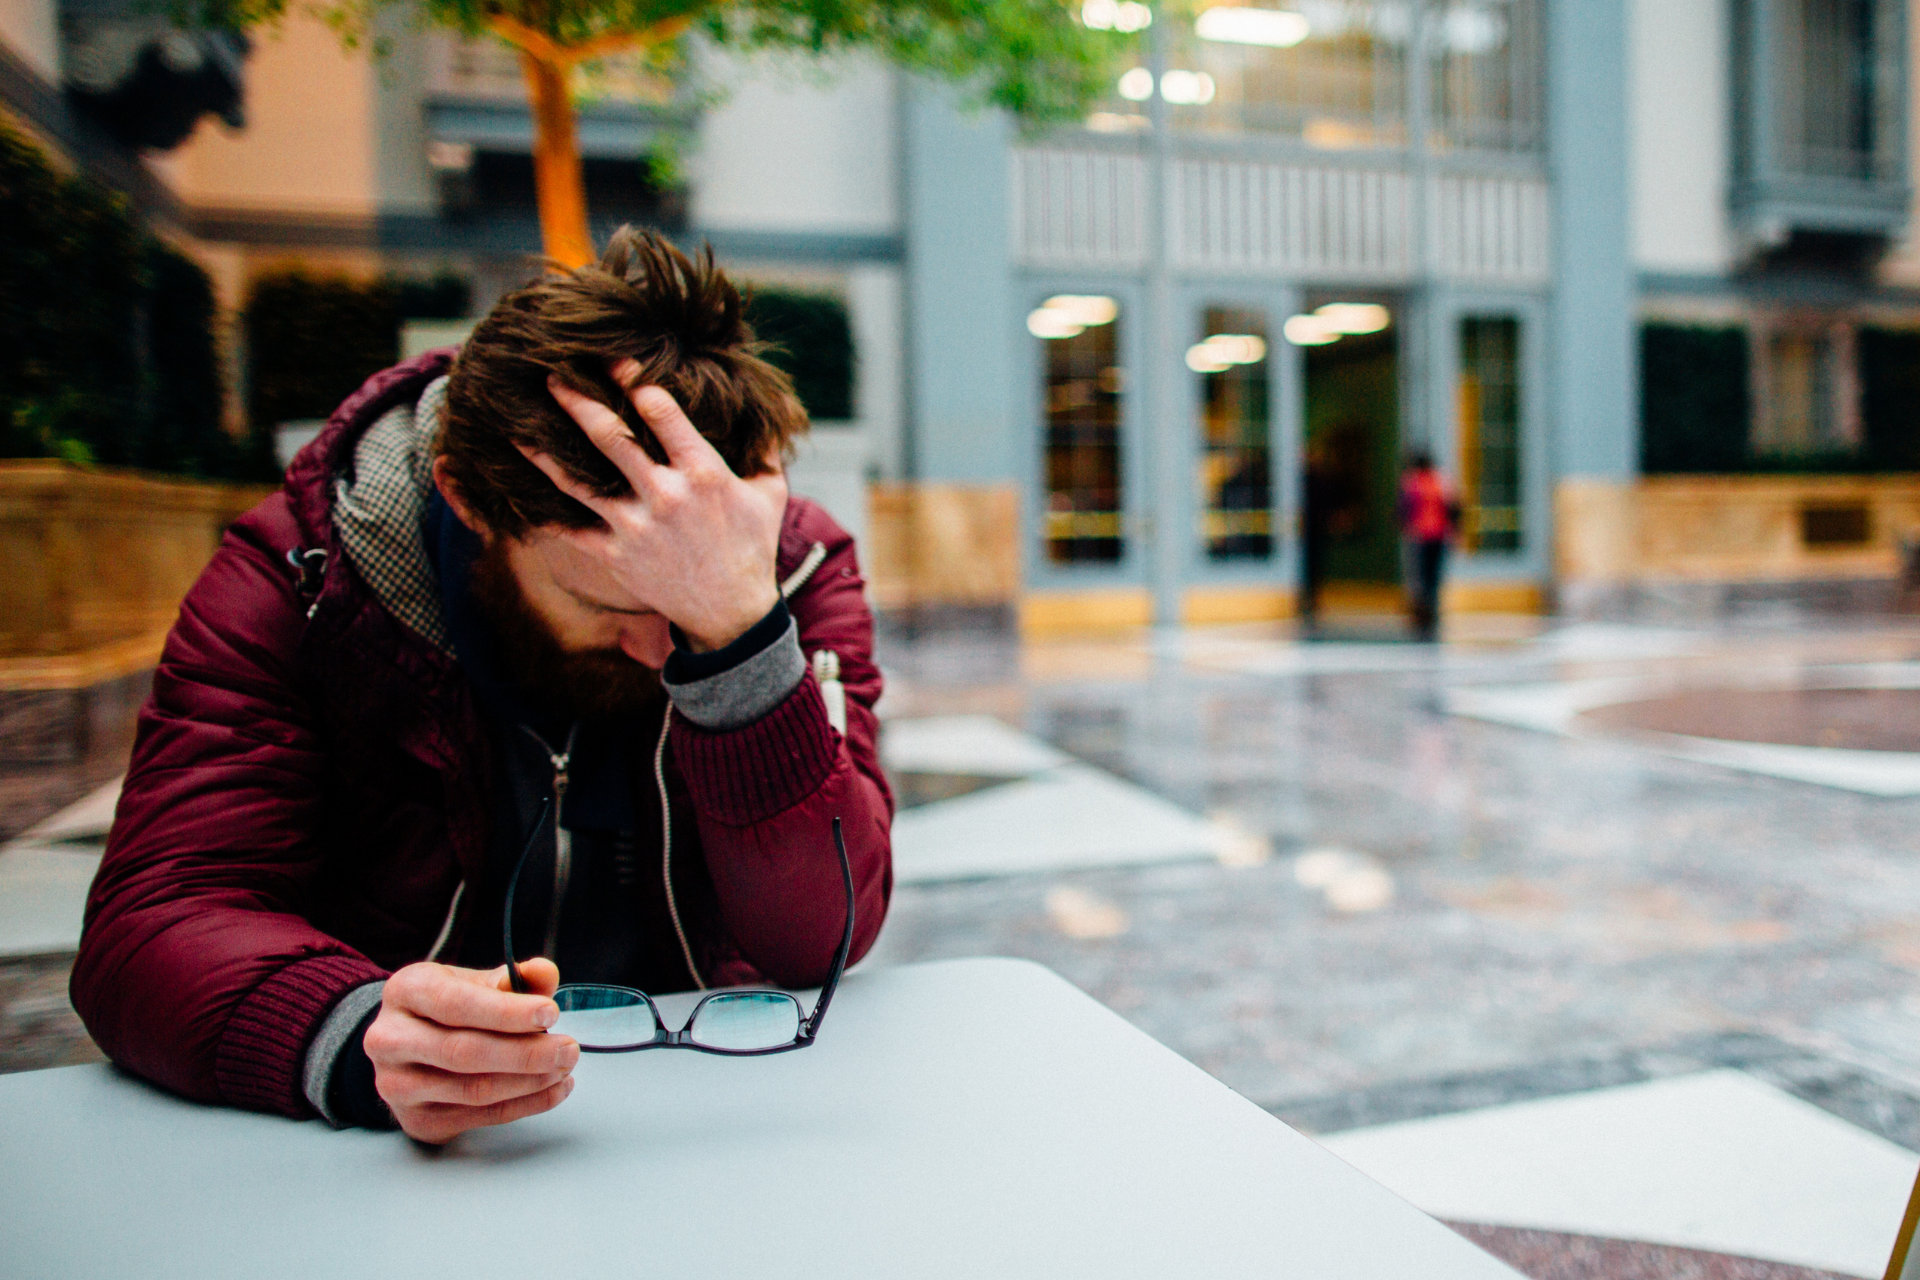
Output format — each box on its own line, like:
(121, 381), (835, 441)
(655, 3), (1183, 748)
(1459, 315), (1523, 551)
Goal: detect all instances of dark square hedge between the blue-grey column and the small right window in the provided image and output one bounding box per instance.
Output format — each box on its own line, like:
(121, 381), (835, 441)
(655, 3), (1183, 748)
(1640, 324), (1751, 474)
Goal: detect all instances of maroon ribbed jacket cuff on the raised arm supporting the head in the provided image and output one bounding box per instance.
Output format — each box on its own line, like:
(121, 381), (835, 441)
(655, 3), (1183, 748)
(672, 672), (839, 827)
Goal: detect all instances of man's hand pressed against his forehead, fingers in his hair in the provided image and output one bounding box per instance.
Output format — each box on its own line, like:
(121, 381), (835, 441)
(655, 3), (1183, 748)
(522, 361), (787, 651)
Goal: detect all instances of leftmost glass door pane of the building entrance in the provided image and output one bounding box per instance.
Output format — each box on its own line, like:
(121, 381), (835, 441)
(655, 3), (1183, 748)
(1027, 294), (1125, 564)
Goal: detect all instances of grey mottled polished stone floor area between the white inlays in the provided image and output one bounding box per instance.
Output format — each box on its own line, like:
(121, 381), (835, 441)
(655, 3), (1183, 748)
(864, 620), (1920, 1148)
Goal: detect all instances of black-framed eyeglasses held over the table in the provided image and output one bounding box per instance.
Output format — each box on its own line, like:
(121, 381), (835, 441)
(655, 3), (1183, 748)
(501, 806), (852, 1057)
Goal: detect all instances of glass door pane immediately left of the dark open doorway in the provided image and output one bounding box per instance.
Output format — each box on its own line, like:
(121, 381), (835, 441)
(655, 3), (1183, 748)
(1187, 307), (1273, 562)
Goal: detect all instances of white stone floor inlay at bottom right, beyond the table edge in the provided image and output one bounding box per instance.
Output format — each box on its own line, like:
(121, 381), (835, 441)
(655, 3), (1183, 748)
(1321, 1071), (1920, 1276)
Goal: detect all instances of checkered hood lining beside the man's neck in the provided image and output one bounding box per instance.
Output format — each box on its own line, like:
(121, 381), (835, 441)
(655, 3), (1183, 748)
(334, 378), (453, 654)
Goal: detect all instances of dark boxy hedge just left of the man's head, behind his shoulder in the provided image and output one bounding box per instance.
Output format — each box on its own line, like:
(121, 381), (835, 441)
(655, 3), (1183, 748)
(246, 271), (399, 427)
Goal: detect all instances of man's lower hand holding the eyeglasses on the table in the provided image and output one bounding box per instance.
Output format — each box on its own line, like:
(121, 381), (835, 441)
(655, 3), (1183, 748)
(363, 960), (580, 1142)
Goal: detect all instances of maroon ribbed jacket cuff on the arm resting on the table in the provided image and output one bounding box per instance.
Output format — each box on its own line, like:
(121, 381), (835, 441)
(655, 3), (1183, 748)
(213, 956), (386, 1119)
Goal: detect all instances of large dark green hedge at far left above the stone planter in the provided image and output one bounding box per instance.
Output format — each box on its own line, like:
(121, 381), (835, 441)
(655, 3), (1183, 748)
(0, 129), (257, 478)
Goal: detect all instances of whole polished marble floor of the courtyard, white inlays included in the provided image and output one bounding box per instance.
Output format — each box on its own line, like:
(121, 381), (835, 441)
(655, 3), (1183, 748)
(11, 618), (1920, 1276)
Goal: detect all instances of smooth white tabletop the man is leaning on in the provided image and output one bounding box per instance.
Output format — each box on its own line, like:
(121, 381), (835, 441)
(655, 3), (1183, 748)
(0, 960), (1513, 1280)
